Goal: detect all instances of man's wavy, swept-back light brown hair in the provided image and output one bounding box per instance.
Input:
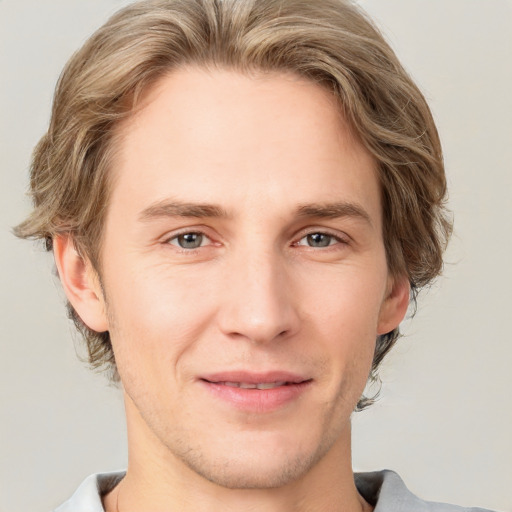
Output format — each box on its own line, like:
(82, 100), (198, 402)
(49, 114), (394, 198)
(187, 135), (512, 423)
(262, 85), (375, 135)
(15, 0), (451, 409)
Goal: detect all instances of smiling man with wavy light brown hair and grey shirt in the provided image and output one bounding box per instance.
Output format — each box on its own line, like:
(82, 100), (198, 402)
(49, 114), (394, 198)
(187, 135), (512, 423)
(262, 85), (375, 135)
(13, 0), (492, 512)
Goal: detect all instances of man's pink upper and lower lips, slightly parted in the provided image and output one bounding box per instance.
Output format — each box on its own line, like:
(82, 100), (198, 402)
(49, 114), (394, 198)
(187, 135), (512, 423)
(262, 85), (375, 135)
(198, 371), (313, 413)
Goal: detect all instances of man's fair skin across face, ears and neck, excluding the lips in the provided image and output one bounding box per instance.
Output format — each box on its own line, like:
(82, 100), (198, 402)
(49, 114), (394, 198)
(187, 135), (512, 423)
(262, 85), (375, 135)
(55, 67), (409, 512)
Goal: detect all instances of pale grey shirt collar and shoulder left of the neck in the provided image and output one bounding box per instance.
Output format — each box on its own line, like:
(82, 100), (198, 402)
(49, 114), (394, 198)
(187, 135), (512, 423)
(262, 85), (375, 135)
(54, 471), (125, 512)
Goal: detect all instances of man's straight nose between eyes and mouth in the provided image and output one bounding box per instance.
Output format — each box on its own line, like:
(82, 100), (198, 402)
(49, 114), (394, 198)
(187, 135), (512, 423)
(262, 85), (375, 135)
(218, 244), (300, 344)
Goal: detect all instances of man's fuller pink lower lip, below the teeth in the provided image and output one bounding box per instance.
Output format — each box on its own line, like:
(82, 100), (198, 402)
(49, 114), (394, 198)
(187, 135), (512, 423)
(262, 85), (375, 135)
(200, 380), (312, 413)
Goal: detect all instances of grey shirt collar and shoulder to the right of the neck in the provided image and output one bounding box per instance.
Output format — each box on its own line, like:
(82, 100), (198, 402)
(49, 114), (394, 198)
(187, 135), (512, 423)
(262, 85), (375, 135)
(354, 470), (491, 512)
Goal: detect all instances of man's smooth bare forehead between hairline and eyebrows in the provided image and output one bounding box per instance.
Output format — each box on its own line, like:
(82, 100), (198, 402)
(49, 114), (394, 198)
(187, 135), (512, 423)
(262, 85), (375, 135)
(111, 67), (380, 224)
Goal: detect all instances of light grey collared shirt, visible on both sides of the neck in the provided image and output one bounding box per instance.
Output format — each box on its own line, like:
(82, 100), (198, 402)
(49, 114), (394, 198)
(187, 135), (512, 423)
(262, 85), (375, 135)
(54, 469), (491, 512)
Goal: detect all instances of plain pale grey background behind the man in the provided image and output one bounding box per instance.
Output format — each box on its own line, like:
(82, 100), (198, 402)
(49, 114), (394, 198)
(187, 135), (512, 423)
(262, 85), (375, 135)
(0, 0), (512, 512)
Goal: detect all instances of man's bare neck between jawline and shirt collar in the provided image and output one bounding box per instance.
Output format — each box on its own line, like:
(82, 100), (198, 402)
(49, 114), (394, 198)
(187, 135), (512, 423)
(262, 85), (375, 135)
(104, 394), (372, 512)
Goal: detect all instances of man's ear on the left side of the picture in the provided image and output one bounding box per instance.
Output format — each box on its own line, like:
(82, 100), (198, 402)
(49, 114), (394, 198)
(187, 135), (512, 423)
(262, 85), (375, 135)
(53, 235), (108, 332)
